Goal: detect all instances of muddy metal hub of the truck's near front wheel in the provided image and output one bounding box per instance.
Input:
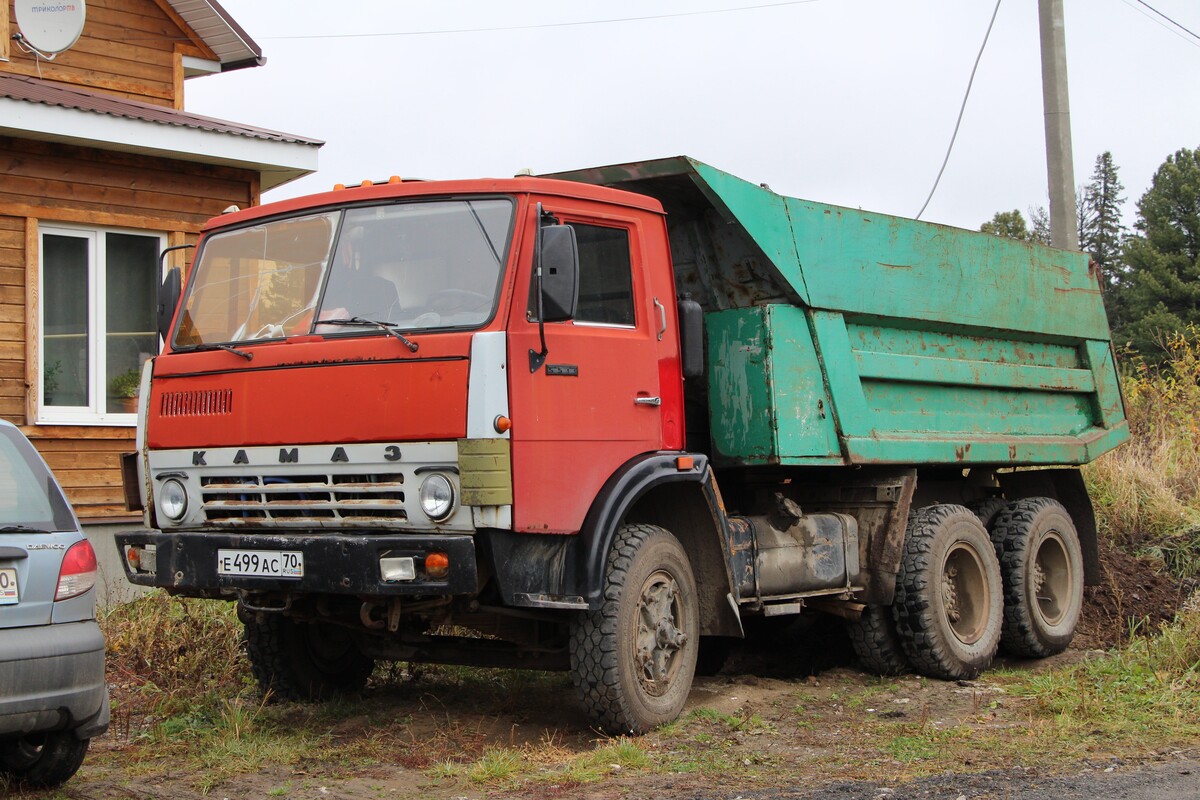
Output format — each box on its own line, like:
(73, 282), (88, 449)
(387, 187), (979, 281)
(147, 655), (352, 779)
(636, 571), (688, 697)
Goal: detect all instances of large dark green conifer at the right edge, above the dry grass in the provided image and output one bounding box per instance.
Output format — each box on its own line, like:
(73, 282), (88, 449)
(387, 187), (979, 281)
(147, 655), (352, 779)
(1117, 148), (1200, 360)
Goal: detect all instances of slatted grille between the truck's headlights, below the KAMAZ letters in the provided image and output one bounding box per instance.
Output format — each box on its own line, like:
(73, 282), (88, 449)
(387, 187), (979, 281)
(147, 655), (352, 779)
(200, 471), (408, 527)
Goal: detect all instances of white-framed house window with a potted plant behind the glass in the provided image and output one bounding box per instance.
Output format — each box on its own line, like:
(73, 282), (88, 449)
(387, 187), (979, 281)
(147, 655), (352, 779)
(38, 225), (166, 425)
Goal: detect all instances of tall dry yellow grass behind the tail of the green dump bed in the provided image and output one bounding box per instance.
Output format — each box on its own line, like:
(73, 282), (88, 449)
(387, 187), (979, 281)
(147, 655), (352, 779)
(1084, 326), (1200, 578)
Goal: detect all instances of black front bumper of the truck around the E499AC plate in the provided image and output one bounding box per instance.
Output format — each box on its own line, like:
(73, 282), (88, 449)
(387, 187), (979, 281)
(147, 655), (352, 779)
(116, 530), (479, 597)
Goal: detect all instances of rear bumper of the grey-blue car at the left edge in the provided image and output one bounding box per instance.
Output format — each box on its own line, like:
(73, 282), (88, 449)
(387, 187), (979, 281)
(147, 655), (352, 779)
(0, 620), (108, 739)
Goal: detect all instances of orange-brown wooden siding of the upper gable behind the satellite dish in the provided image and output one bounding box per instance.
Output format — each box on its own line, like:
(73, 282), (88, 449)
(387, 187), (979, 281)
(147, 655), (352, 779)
(0, 0), (212, 108)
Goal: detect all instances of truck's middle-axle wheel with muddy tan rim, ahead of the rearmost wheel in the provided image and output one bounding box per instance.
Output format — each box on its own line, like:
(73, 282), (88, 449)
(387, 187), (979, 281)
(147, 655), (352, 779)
(895, 505), (1003, 679)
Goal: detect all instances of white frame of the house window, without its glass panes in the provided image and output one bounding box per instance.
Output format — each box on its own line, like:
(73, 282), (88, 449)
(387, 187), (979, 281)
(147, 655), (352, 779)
(37, 221), (167, 427)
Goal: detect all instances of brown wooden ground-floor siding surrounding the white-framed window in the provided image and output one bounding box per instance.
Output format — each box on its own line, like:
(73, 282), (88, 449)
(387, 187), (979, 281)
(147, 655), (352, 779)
(0, 137), (259, 522)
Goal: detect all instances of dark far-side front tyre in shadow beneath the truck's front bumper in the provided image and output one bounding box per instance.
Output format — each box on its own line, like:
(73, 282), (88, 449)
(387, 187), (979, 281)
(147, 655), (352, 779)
(245, 614), (374, 700)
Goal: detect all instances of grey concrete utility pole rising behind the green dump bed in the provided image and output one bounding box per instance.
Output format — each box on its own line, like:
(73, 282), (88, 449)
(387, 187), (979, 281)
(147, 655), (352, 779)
(1038, 0), (1079, 249)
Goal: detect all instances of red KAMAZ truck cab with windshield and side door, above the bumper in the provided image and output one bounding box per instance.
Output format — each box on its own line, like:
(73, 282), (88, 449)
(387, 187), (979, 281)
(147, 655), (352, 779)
(145, 179), (683, 534)
